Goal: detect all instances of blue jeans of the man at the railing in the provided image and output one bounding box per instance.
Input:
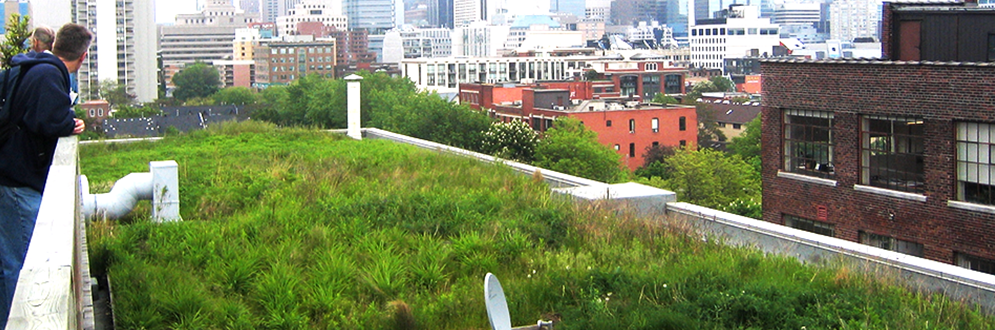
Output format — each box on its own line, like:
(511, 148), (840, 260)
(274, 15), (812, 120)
(0, 185), (41, 329)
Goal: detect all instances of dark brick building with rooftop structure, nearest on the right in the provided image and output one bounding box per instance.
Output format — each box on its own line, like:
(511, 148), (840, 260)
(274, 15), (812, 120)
(761, 3), (995, 273)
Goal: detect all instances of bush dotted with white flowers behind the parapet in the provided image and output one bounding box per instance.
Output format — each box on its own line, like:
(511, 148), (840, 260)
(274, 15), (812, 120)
(481, 120), (539, 163)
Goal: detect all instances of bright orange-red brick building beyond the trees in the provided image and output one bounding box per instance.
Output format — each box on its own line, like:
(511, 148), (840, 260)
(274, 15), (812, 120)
(459, 81), (698, 170)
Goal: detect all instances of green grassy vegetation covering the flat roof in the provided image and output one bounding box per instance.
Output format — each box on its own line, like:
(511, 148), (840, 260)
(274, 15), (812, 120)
(81, 122), (995, 329)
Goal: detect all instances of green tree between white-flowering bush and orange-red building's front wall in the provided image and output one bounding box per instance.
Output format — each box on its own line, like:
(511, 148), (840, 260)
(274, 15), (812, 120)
(534, 117), (625, 183)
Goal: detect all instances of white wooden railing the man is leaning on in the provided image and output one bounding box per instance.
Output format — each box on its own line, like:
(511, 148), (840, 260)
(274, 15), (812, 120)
(7, 136), (94, 329)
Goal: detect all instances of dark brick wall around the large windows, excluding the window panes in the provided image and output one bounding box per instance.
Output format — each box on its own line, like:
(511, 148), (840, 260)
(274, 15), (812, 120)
(761, 61), (995, 263)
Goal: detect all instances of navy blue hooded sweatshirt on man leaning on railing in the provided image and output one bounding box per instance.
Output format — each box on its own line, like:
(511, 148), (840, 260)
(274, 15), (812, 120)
(0, 52), (76, 192)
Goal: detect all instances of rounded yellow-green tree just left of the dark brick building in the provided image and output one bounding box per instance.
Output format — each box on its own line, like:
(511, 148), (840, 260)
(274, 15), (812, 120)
(661, 148), (760, 208)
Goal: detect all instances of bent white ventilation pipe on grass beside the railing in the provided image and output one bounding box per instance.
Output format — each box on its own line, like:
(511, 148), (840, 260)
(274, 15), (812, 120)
(80, 160), (182, 222)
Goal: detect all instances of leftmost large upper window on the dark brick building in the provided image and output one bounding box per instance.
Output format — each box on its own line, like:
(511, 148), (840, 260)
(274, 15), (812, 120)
(784, 110), (836, 179)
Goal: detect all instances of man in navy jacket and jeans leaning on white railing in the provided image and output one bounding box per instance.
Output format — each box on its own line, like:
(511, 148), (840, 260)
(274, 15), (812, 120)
(0, 24), (93, 328)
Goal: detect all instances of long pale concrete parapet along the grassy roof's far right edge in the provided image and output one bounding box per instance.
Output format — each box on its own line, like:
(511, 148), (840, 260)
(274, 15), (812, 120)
(364, 129), (995, 314)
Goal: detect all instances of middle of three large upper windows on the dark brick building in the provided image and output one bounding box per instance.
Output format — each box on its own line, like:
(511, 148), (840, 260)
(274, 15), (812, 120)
(860, 116), (924, 193)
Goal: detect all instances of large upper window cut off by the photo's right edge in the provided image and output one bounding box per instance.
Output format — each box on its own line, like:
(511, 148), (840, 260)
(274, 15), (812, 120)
(957, 123), (995, 205)
